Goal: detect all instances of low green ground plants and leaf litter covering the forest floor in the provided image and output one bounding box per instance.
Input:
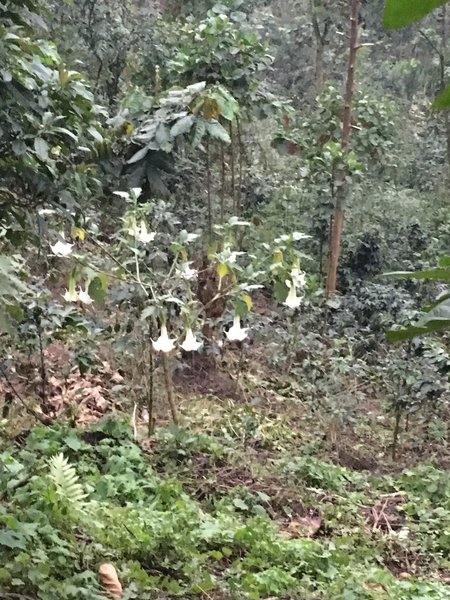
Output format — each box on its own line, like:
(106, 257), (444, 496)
(0, 338), (450, 600)
